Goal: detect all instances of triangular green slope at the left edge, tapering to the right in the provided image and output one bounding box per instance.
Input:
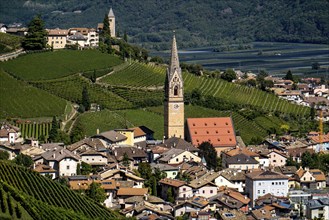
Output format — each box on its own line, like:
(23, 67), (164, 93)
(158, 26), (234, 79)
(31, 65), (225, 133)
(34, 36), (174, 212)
(0, 70), (67, 119)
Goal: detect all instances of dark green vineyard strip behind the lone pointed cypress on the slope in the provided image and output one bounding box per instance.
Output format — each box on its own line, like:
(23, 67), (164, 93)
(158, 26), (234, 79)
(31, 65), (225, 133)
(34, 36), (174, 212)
(33, 75), (132, 110)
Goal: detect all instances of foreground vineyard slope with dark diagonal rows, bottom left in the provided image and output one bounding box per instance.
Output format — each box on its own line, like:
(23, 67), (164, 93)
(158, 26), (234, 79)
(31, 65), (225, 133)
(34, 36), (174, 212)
(0, 162), (121, 220)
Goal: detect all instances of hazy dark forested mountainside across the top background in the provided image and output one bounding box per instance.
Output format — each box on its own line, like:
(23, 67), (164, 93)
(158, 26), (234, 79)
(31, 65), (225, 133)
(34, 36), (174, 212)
(0, 0), (329, 49)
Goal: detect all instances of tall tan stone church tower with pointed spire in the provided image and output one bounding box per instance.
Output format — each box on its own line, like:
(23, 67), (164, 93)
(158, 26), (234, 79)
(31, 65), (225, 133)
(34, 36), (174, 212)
(164, 35), (184, 139)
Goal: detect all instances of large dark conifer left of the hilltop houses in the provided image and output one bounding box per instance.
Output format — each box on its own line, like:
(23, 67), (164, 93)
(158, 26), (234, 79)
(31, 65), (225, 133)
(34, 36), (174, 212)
(22, 15), (47, 50)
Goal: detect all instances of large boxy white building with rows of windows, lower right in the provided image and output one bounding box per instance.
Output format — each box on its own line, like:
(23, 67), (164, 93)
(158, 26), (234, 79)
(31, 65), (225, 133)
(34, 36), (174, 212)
(246, 171), (289, 206)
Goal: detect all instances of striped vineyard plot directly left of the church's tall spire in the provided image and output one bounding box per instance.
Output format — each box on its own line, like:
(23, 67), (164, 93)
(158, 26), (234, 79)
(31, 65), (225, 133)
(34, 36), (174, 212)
(101, 62), (165, 88)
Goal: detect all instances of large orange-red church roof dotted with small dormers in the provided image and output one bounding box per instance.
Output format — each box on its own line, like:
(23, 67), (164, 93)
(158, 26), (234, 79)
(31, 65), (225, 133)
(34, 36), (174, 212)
(187, 117), (237, 147)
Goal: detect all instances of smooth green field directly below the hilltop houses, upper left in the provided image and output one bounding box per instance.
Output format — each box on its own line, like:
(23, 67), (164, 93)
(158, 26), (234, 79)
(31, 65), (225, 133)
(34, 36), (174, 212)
(0, 50), (122, 81)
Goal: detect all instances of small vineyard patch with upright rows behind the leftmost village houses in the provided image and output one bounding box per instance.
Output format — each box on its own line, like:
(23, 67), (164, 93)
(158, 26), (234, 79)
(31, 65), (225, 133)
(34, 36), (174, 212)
(15, 122), (51, 139)
